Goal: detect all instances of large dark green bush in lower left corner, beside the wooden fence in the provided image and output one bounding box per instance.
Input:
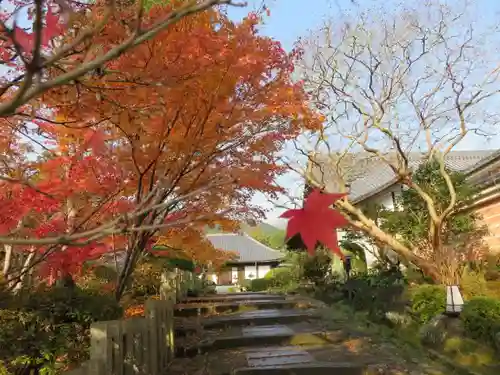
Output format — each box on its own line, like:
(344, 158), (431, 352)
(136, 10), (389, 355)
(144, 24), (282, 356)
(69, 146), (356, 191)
(0, 287), (123, 371)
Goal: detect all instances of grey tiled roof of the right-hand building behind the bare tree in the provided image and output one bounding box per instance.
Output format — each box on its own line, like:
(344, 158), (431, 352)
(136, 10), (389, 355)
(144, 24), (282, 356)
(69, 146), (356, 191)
(311, 150), (500, 202)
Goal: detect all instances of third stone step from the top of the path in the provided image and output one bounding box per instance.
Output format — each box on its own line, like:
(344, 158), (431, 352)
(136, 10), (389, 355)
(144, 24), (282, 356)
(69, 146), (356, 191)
(175, 309), (318, 337)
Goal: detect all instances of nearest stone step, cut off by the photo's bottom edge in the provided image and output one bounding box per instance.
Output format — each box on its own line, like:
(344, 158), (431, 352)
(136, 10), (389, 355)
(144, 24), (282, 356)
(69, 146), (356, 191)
(233, 362), (366, 375)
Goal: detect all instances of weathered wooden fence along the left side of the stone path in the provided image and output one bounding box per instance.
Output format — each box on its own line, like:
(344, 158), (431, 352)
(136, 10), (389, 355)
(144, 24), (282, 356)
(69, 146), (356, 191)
(66, 271), (196, 375)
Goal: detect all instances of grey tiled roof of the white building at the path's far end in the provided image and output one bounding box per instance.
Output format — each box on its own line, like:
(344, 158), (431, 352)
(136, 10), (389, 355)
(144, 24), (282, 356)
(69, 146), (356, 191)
(207, 233), (284, 263)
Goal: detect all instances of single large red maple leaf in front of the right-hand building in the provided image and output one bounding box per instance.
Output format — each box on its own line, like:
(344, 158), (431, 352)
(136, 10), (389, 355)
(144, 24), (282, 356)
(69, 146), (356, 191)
(280, 189), (347, 258)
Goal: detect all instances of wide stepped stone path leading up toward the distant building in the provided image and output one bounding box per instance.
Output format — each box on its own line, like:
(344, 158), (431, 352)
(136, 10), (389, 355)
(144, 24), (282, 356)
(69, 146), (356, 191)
(168, 293), (452, 375)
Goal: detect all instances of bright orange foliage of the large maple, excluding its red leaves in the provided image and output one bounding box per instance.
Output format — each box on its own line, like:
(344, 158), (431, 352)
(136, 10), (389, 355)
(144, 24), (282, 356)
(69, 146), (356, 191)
(28, 1), (321, 270)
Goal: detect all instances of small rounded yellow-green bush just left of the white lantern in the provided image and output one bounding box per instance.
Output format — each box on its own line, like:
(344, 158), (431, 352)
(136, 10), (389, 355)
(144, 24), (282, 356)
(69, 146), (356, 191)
(411, 284), (446, 323)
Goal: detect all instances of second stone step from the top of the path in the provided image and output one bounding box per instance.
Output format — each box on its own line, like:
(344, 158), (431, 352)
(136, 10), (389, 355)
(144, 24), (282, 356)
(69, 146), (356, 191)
(174, 299), (311, 317)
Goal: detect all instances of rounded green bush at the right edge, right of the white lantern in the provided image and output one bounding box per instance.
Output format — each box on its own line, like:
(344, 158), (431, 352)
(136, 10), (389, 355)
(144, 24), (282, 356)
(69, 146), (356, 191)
(460, 297), (500, 345)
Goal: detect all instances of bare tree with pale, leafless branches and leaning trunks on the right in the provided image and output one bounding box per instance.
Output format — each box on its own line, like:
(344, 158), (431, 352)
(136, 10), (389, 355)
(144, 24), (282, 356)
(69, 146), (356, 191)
(285, 2), (499, 282)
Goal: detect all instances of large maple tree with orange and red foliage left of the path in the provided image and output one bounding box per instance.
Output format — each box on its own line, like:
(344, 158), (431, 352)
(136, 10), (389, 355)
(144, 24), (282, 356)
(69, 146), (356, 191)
(0, 2), (320, 298)
